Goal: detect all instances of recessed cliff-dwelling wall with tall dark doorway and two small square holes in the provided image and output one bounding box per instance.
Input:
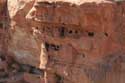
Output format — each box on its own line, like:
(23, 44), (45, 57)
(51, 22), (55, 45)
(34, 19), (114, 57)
(41, 26), (82, 39)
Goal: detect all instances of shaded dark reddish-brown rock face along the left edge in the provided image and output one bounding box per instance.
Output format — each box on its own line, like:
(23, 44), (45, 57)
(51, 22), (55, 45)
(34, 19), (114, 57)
(0, 0), (8, 53)
